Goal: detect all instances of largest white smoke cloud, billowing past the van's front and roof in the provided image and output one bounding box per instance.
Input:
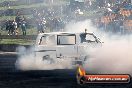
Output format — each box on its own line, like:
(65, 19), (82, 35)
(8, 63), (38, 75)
(66, 20), (132, 74)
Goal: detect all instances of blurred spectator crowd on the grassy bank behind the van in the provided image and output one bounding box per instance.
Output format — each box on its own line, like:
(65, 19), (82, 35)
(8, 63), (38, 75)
(0, 0), (132, 35)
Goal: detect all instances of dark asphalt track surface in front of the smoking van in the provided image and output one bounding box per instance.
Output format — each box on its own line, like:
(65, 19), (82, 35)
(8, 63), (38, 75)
(0, 54), (132, 88)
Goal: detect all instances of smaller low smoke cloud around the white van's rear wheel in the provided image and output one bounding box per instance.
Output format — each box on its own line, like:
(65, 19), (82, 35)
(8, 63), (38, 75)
(15, 47), (71, 70)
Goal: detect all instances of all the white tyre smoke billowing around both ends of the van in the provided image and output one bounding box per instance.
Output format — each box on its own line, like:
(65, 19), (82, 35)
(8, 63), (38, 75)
(16, 20), (132, 74)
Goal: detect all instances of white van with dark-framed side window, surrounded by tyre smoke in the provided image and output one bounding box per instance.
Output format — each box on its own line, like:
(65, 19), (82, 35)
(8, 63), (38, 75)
(35, 32), (102, 65)
